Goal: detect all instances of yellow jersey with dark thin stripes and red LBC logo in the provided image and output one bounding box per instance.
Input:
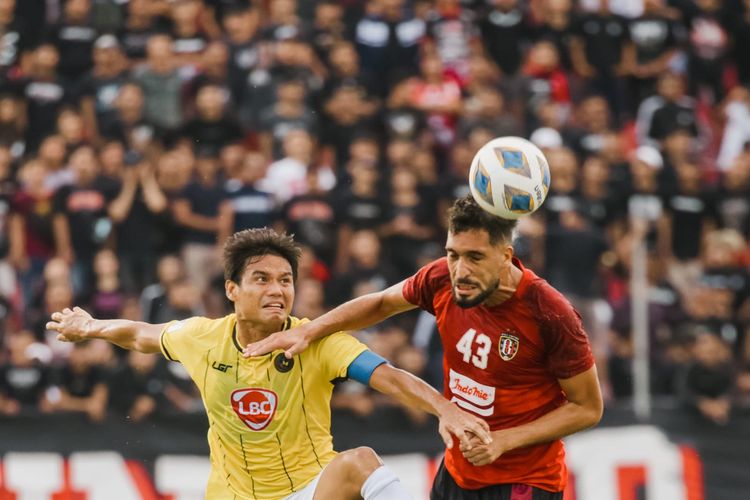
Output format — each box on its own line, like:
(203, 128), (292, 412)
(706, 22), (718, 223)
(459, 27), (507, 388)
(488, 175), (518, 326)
(160, 314), (367, 500)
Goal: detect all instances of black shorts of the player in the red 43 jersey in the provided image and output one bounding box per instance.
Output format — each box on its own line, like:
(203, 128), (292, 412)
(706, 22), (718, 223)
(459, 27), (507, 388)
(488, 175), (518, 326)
(430, 462), (563, 500)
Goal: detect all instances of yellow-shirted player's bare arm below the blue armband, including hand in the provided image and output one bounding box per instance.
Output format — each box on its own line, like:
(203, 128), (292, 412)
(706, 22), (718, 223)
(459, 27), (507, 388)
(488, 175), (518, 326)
(370, 363), (491, 449)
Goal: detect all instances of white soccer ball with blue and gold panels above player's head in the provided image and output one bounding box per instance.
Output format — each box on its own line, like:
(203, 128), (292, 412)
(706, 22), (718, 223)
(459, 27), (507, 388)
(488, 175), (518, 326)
(469, 137), (550, 219)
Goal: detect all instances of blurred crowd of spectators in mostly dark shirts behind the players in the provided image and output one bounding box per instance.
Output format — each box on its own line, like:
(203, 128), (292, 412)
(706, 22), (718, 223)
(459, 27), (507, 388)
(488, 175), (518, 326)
(0, 0), (750, 424)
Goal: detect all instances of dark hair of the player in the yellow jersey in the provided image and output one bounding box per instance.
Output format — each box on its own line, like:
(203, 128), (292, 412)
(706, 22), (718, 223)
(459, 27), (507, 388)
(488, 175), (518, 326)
(224, 227), (301, 283)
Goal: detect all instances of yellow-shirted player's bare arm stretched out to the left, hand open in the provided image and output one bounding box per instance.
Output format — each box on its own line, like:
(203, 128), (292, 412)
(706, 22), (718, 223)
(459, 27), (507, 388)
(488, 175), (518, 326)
(47, 307), (166, 354)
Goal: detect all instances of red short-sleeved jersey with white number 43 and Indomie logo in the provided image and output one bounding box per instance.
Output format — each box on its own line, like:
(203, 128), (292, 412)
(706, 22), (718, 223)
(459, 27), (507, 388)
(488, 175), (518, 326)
(403, 258), (594, 492)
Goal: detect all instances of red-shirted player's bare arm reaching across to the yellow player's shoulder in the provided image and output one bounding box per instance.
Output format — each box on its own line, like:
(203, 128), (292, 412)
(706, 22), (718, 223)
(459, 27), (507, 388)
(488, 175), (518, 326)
(247, 281), (417, 358)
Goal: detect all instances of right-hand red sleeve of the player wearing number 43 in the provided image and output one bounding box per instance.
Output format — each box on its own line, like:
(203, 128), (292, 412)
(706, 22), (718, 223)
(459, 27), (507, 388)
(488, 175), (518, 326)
(535, 282), (594, 379)
